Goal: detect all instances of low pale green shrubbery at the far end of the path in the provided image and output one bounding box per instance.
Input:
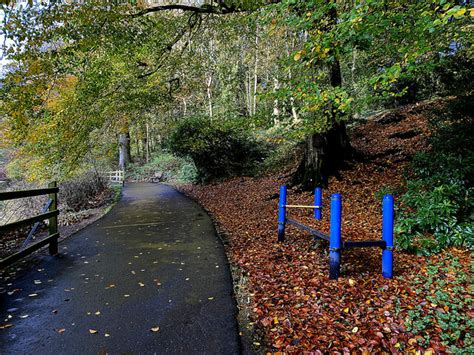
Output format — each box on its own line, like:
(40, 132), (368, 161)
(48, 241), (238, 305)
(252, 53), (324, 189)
(127, 151), (197, 183)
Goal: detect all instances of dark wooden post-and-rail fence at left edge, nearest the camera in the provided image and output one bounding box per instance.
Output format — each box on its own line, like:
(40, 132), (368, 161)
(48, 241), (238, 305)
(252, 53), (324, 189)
(0, 182), (59, 268)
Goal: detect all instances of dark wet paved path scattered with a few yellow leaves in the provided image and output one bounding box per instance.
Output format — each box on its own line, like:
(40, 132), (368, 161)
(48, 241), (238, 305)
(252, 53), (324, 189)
(0, 184), (240, 354)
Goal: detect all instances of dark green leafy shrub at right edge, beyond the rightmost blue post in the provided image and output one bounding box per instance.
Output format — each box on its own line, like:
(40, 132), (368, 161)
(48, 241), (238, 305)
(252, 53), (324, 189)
(396, 98), (474, 254)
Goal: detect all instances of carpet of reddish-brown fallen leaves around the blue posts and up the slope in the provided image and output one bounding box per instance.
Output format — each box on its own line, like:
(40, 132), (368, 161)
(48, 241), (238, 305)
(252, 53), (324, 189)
(181, 105), (473, 353)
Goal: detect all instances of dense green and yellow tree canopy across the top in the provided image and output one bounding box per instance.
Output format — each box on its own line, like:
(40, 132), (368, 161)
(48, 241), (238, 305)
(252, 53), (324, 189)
(2, 0), (473, 181)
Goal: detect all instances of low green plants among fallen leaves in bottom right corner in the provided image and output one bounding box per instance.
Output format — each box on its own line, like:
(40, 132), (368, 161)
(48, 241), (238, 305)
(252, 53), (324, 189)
(405, 254), (474, 354)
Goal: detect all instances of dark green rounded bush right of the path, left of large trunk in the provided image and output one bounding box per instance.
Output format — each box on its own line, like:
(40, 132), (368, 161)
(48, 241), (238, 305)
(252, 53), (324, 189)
(167, 118), (265, 182)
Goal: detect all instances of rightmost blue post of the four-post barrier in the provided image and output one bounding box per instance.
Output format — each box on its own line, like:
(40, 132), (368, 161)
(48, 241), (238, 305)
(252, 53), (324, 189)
(382, 195), (393, 279)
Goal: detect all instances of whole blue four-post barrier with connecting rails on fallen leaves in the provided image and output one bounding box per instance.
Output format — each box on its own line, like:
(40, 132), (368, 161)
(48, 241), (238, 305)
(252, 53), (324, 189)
(278, 186), (394, 280)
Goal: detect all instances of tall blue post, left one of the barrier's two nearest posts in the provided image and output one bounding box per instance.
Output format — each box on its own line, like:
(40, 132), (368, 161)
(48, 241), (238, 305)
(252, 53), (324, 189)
(329, 194), (342, 280)
